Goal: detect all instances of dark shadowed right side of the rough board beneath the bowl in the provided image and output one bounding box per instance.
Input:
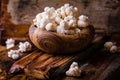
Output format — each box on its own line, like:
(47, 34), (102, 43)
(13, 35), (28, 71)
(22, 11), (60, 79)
(51, 38), (109, 79)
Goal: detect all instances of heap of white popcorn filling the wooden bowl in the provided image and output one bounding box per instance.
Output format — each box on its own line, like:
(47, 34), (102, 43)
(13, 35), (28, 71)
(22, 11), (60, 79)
(33, 3), (90, 34)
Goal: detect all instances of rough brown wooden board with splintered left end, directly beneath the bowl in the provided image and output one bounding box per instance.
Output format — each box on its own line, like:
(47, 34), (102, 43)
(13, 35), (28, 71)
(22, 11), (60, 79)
(10, 37), (109, 79)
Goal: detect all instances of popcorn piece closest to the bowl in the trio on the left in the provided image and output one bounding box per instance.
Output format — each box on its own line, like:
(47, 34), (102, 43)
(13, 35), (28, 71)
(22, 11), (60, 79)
(18, 41), (32, 52)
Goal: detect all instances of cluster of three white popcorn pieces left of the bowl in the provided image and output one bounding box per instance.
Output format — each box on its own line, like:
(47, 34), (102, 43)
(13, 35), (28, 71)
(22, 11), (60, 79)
(6, 38), (32, 59)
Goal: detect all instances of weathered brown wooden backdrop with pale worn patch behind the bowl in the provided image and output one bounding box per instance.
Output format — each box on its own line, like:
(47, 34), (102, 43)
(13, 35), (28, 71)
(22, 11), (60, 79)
(1, 0), (120, 40)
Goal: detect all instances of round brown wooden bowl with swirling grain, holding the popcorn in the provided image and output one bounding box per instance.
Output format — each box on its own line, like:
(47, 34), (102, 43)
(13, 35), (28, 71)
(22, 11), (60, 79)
(29, 25), (95, 54)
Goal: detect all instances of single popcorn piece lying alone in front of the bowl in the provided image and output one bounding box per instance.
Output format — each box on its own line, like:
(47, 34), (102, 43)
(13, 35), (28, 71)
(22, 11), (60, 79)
(66, 62), (81, 76)
